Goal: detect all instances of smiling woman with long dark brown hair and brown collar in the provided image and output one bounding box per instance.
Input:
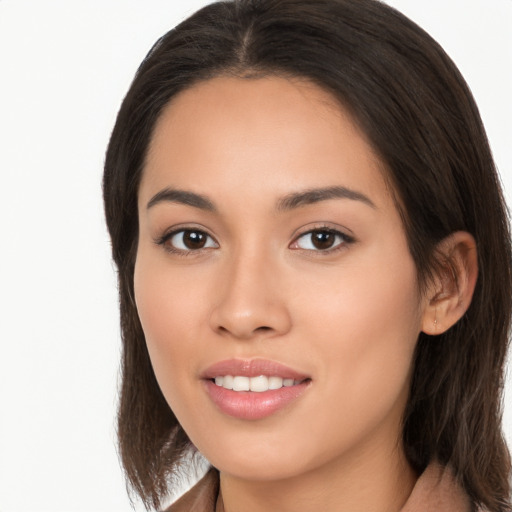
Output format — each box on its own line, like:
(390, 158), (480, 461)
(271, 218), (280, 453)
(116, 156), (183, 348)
(104, 0), (511, 512)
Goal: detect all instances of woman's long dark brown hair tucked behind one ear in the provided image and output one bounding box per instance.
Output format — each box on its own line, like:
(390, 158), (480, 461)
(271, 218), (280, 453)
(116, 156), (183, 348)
(103, 0), (512, 512)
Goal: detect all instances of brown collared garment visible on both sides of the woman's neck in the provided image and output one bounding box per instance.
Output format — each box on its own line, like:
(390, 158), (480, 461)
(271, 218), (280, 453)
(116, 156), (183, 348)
(165, 464), (472, 512)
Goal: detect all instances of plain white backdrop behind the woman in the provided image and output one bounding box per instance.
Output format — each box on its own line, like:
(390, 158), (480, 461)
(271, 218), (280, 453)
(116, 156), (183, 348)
(0, 0), (512, 512)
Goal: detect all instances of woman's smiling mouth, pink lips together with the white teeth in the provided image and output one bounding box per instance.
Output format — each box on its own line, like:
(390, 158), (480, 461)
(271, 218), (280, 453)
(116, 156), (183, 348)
(201, 359), (311, 420)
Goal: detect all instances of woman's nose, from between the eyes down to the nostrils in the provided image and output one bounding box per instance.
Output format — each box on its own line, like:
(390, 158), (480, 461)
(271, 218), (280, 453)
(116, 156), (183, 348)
(210, 249), (291, 340)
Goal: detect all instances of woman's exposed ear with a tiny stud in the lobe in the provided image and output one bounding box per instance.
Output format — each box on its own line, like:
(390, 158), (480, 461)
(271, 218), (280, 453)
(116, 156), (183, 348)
(422, 231), (478, 335)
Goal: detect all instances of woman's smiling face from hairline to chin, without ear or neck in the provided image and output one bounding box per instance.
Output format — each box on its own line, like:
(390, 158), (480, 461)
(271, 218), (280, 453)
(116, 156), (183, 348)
(135, 77), (424, 480)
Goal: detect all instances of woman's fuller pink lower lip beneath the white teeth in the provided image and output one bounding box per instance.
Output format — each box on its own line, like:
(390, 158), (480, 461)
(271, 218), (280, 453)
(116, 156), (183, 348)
(203, 380), (310, 420)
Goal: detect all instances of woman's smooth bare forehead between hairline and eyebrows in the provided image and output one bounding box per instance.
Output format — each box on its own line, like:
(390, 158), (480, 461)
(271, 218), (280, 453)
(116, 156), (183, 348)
(140, 77), (387, 210)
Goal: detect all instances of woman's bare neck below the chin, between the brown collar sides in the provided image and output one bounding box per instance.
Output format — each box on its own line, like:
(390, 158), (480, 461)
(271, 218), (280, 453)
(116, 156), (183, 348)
(218, 440), (417, 512)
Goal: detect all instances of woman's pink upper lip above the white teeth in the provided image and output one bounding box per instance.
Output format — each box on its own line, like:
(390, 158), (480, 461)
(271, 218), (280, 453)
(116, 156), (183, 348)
(201, 359), (309, 381)
